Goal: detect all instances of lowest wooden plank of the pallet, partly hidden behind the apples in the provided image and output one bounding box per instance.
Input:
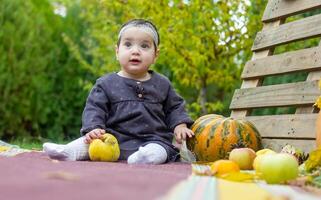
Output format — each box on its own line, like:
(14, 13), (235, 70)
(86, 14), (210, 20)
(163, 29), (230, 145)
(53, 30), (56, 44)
(262, 139), (316, 153)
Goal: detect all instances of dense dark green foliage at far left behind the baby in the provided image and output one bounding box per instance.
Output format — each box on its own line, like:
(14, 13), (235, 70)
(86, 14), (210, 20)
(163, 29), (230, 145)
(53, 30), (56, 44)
(0, 0), (87, 140)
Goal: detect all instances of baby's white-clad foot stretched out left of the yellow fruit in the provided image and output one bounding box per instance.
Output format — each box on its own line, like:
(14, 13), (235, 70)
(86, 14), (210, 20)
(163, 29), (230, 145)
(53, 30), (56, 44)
(43, 142), (76, 161)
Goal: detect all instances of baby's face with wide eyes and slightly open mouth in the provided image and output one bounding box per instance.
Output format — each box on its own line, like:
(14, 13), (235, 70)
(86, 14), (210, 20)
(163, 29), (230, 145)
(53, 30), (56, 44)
(116, 27), (158, 76)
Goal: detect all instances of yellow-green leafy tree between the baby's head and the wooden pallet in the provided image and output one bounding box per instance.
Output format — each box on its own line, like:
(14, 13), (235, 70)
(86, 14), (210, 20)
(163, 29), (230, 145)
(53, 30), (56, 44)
(153, 1), (246, 116)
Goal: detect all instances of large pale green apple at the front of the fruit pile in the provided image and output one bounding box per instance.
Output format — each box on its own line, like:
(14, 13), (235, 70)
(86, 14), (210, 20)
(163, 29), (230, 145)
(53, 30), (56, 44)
(259, 153), (299, 184)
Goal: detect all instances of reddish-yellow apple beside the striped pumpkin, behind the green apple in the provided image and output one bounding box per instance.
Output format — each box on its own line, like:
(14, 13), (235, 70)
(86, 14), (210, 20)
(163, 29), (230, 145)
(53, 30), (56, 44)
(229, 148), (256, 170)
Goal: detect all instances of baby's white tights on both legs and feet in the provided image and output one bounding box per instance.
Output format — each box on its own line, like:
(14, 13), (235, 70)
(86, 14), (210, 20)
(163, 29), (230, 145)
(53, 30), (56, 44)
(43, 137), (167, 164)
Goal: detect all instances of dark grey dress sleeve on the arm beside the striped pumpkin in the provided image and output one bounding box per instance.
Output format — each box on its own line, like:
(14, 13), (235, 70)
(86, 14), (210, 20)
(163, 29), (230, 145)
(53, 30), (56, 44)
(164, 85), (193, 131)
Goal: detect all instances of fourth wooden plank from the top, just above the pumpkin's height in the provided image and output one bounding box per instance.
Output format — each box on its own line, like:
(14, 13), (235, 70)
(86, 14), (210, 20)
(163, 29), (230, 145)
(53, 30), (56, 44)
(230, 81), (320, 109)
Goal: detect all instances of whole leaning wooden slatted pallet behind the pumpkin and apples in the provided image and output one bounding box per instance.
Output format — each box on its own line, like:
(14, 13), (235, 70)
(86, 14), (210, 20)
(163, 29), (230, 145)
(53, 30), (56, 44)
(230, 0), (321, 152)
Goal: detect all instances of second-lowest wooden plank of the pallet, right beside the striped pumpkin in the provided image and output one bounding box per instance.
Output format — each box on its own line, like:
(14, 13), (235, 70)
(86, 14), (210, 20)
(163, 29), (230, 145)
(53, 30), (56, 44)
(239, 114), (317, 139)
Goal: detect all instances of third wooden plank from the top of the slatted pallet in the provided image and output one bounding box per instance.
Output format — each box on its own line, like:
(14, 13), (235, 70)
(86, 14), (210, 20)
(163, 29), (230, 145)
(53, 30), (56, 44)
(241, 46), (321, 79)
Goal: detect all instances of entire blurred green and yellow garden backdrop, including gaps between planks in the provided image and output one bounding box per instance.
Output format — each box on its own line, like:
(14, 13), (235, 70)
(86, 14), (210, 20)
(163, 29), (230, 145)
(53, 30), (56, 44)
(0, 0), (318, 147)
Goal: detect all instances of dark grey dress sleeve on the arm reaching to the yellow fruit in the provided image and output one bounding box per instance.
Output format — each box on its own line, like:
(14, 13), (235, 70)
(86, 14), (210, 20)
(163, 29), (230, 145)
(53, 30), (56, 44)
(80, 79), (109, 135)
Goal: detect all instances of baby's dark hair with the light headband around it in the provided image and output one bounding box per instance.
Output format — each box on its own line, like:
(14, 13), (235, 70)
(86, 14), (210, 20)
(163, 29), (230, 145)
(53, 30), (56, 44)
(117, 19), (160, 49)
